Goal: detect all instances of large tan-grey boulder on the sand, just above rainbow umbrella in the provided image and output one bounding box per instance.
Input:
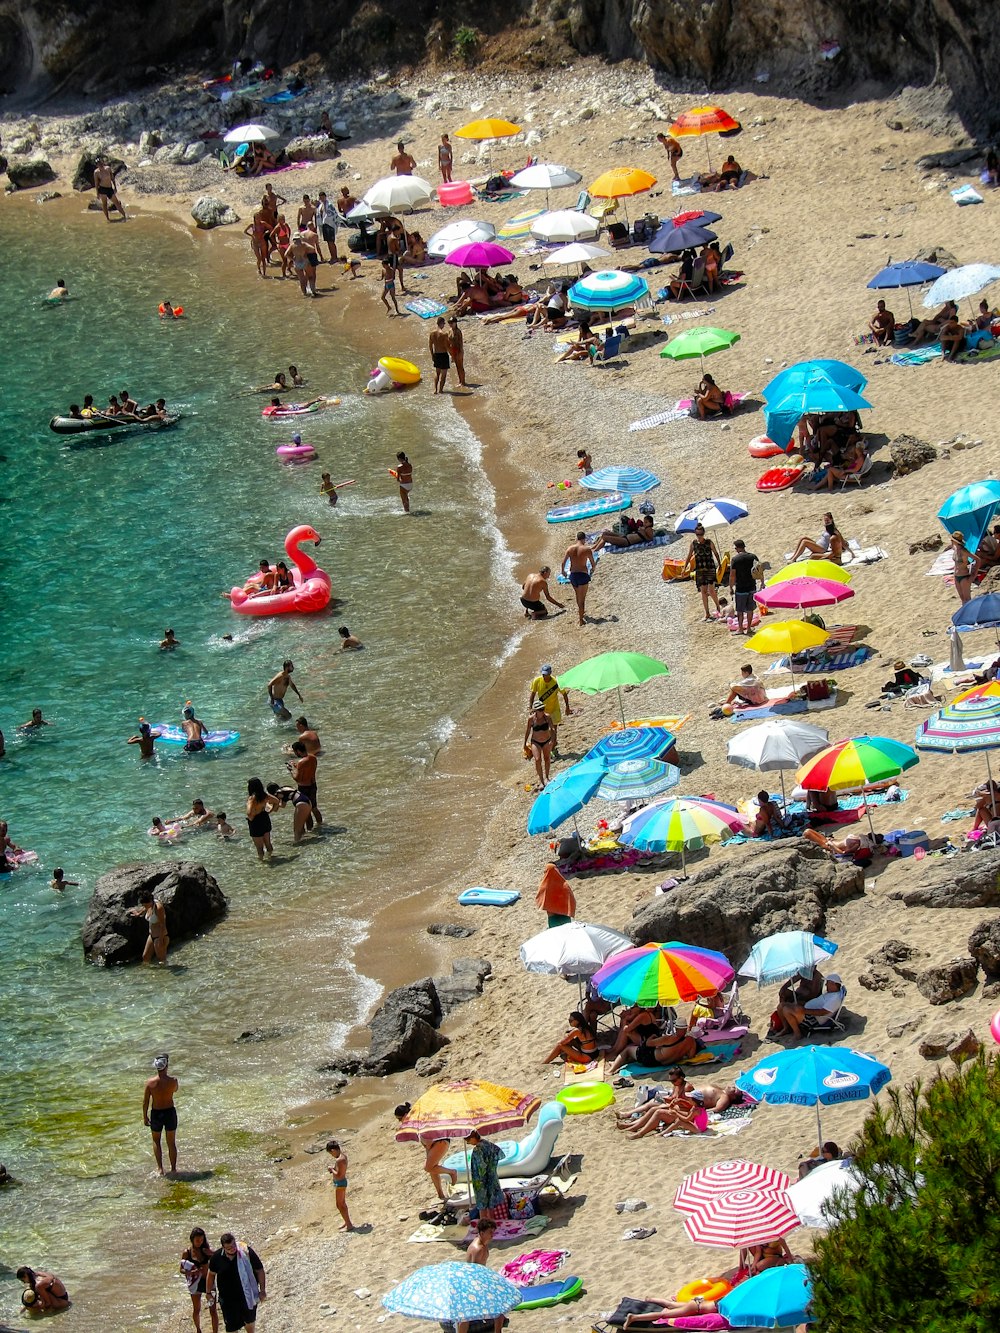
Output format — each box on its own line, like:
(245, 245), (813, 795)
(628, 840), (864, 964)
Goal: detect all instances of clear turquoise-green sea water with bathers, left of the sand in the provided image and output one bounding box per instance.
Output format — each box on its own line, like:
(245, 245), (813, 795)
(0, 200), (509, 1328)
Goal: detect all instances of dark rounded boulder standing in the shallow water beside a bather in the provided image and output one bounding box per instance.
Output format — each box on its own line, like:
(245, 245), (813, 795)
(81, 861), (228, 965)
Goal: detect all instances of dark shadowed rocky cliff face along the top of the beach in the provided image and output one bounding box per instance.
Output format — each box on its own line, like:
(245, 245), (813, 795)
(0, 0), (1000, 131)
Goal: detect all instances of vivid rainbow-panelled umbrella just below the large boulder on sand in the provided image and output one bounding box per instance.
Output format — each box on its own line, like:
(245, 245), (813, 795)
(593, 940), (735, 1008)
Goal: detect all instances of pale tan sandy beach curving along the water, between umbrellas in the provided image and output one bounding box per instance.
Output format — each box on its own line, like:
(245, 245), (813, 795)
(4, 61), (1000, 1333)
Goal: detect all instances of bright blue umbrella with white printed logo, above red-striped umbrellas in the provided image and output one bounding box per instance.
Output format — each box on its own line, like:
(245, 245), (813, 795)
(736, 1046), (892, 1148)
